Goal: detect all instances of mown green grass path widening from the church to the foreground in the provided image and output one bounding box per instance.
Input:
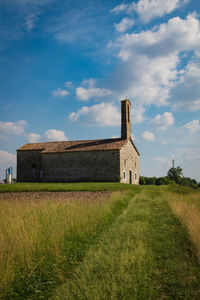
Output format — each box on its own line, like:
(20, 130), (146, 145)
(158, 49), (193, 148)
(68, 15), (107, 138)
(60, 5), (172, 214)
(52, 186), (200, 300)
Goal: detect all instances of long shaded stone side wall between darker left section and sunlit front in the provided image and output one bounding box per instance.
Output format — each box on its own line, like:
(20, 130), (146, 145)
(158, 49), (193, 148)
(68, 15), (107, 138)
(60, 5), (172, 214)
(41, 150), (120, 182)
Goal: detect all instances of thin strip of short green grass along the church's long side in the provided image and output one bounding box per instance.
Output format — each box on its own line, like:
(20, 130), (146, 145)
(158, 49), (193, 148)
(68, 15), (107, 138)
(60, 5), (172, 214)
(0, 182), (139, 193)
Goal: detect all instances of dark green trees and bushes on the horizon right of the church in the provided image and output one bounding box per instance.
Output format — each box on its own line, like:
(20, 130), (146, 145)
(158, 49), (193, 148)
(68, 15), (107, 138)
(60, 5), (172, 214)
(140, 167), (200, 189)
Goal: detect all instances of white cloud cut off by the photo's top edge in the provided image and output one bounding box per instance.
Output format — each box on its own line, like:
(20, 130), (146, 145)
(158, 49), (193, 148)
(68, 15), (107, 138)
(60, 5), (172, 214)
(111, 0), (189, 23)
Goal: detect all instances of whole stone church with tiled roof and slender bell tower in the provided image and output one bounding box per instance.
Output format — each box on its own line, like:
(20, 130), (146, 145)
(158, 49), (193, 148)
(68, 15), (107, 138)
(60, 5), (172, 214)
(17, 99), (140, 184)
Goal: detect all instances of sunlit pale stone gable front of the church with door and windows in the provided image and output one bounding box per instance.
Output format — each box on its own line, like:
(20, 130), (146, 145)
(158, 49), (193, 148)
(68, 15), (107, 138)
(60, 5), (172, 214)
(120, 141), (139, 184)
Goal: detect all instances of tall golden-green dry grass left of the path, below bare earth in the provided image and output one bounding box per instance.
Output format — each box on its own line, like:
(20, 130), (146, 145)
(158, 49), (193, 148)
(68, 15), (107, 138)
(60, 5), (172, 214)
(0, 193), (111, 298)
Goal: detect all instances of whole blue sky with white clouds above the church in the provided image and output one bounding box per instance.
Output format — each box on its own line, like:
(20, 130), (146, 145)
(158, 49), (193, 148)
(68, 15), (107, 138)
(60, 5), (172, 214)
(0, 0), (200, 181)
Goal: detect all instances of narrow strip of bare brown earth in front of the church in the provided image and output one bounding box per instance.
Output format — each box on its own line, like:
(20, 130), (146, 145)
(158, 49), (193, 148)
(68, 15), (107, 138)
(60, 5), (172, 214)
(0, 191), (112, 202)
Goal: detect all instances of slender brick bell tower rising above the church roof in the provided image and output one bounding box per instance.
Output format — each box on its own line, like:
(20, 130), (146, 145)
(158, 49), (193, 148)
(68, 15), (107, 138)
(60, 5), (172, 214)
(121, 99), (131, 140)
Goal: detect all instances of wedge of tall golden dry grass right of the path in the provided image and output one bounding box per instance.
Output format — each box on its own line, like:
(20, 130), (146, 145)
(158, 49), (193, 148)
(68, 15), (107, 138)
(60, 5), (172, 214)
(169, 193), (200, 259)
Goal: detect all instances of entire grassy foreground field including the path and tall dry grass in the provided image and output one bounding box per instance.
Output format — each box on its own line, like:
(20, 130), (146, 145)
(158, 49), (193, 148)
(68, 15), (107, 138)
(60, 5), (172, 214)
(0, 183), (200, 300)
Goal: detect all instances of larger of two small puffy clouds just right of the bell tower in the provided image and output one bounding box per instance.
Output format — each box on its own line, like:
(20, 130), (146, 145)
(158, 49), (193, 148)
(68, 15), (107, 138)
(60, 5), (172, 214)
(150, 112), (174, 130)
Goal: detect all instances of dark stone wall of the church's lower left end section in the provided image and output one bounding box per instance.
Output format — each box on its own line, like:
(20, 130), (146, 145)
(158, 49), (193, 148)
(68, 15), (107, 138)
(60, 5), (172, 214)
(17, 150), (42, 182)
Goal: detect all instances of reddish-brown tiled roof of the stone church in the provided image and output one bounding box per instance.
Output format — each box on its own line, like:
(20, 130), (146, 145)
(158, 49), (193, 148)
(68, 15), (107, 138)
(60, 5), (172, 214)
(17, 138), (136, 154)
